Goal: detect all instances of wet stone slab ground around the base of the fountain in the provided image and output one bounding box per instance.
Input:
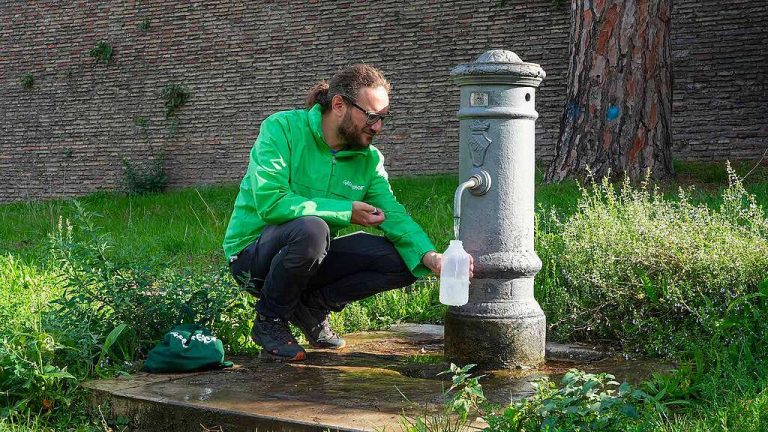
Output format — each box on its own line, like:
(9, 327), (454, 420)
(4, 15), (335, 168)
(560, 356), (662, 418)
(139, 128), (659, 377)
(85, 325), (668, 431)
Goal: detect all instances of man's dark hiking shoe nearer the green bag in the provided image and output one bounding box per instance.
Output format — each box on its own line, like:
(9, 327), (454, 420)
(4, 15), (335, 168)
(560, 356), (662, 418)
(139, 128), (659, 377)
(251, 315), (307, 361)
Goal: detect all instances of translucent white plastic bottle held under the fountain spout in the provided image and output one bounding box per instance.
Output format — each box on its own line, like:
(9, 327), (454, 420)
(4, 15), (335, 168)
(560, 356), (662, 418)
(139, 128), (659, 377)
(440, 240), (469, 306)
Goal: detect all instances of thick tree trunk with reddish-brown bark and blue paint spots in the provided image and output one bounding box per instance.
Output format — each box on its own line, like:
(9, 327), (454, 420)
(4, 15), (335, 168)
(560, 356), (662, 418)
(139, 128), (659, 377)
(545, 0), (673, 182)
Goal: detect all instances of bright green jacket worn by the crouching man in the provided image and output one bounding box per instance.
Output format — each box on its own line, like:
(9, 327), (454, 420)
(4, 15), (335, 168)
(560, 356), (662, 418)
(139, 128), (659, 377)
(224, 105), (435, 276)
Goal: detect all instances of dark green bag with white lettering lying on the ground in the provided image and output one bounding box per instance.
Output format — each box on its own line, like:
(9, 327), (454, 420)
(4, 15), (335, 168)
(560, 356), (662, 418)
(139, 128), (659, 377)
(144, 324), (234, 372)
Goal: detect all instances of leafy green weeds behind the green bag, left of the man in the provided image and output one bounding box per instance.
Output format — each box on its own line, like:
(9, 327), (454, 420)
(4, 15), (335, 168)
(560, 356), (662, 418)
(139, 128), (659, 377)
(51, 204), (255, 361)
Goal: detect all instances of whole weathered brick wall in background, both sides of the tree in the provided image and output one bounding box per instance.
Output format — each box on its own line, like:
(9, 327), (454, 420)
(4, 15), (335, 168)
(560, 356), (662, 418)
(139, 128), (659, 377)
(0, 0), (768, 201)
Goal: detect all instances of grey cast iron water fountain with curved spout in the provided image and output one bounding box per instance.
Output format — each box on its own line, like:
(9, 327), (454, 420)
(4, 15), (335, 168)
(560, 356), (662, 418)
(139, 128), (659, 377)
(445, 50), (546, 368)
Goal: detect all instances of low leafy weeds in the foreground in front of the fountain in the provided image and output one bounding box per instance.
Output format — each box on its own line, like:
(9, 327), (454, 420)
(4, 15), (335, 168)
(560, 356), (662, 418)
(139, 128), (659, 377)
(408, 364), (669, 432)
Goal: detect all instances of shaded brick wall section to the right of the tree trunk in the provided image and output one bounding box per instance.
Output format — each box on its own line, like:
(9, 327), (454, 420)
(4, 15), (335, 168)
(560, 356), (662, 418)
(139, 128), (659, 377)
(671, 0), (768, 160)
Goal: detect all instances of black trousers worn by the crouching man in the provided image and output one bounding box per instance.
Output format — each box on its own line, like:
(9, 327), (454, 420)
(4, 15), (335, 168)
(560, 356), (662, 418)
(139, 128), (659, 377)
(230, 216), (416, 320)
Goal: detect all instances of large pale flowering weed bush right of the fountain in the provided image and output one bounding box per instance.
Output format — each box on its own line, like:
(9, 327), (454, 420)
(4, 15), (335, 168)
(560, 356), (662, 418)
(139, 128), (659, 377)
(537, 164), (768, 356)
